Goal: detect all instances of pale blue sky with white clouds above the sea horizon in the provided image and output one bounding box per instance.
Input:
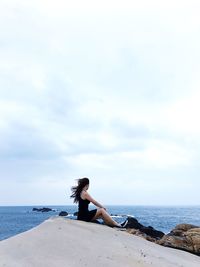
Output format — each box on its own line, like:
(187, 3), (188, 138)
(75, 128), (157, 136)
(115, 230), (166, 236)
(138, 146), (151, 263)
(0, 0), (200, 206)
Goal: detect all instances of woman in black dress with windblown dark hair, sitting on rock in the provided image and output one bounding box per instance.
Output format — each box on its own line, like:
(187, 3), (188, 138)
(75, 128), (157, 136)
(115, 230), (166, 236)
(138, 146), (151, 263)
(71, 178), (122, 228)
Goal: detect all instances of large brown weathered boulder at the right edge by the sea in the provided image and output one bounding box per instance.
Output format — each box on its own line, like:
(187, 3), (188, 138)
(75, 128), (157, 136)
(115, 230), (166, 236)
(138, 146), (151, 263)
(156, 224), (200, 255)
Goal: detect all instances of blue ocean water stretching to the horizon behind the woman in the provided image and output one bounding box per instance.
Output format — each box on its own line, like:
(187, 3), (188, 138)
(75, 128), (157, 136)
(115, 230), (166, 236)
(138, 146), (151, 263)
(0, 205), (200, 240)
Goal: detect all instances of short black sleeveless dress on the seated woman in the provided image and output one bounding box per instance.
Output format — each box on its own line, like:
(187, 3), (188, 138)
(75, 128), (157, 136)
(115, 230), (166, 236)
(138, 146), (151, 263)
(77, 196), (97, 222)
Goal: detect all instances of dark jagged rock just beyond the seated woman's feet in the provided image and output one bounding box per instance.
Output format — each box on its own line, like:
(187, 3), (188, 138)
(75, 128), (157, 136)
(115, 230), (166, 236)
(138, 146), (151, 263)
(126, 217), (165, 242)
